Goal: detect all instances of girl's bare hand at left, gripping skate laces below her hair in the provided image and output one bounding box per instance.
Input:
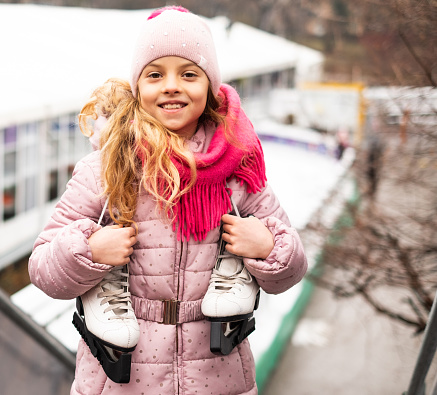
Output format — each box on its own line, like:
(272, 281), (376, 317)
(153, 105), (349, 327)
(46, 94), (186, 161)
(88, 225), (137, 266)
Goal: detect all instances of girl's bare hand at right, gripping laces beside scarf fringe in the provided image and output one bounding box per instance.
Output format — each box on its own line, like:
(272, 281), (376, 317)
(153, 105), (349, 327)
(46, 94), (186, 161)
(222, 214), (274, 259)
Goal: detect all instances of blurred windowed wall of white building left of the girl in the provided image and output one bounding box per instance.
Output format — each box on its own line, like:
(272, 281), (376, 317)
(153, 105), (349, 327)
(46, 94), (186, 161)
(0, 113), (90, 222)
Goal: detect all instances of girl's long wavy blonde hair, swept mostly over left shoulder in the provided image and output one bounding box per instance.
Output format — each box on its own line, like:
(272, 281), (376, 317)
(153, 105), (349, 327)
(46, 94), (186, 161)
(79, 79), (227, 225)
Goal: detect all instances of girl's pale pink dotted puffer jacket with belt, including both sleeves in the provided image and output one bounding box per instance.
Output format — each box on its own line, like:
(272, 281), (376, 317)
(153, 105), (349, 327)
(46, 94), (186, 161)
(29, 128), (307, 395)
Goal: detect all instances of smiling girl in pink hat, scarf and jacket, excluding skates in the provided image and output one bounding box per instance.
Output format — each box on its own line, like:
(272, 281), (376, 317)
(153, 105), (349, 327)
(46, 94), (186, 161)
(29, 7), (307, 395)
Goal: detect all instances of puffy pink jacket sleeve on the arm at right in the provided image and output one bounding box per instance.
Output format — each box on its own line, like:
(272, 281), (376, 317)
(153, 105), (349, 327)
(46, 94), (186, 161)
(235, 185), (308, 294)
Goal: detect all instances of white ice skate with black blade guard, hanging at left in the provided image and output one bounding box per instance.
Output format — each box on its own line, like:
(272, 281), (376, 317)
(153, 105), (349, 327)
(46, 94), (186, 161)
(73, 266), (140, 383)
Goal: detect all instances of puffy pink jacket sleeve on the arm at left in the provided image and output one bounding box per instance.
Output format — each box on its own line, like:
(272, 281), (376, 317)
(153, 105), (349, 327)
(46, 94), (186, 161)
(29, 153), (112, 299)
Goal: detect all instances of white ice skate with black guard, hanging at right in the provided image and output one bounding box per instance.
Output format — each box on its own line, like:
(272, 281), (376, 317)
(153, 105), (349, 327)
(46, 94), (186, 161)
(201, 234), (260, 355)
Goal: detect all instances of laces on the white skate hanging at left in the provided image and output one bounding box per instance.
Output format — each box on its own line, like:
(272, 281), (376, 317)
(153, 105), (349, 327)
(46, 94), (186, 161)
(97, 266), (133, 320)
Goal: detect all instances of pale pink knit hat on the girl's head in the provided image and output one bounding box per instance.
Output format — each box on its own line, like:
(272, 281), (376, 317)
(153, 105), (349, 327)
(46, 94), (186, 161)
(130, 7), (221, 97)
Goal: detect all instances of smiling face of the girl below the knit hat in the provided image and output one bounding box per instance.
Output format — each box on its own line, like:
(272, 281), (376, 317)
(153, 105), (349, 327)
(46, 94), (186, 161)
(138, 56), (209, 139)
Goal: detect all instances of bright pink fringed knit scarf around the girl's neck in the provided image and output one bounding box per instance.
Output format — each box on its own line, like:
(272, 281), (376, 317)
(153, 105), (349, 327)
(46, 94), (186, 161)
(173, 84), (267, 240)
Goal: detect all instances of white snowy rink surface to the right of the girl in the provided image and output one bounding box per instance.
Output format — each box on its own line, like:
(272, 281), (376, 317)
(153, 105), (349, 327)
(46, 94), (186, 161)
(249, 135), (353, 361)
